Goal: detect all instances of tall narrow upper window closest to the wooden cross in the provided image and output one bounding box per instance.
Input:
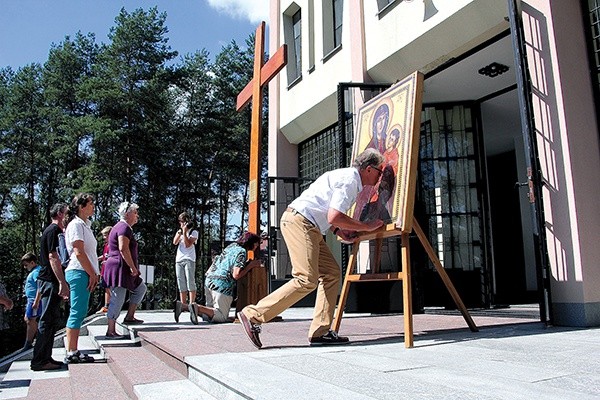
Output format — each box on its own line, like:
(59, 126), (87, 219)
(283, 3), (302, 87)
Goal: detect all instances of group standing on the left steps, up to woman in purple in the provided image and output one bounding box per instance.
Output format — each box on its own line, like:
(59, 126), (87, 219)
(24, 198), (146, 371)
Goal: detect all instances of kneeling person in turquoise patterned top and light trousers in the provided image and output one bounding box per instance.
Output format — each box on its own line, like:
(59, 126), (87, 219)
(189, 232), (261, 324)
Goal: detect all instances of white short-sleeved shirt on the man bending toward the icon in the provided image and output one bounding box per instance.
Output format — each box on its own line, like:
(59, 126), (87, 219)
(289, 167), (363, 234)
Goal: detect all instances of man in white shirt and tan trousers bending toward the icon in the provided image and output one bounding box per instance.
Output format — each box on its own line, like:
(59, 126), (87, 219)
(238, 149), (385, 349)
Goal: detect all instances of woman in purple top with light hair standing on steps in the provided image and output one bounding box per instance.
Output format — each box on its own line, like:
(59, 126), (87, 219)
(102, 201), (146, 338)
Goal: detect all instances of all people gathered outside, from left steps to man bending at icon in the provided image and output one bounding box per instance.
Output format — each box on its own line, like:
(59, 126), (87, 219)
(10, 148), (385, 371)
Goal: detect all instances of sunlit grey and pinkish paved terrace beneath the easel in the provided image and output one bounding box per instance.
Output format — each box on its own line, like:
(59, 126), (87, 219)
(0, 306), (600, 400)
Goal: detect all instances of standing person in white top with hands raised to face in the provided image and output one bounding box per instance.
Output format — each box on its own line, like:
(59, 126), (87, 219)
(173, 212), (198, 322)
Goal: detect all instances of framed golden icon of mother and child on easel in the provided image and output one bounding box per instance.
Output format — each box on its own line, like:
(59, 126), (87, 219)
(350, 72), (423, 231)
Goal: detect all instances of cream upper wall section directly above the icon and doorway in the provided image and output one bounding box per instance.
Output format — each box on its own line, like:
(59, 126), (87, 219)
(364, 0), (508, 82)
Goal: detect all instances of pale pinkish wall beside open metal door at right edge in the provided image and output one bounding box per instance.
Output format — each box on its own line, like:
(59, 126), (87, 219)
(522, 0), (600, 325)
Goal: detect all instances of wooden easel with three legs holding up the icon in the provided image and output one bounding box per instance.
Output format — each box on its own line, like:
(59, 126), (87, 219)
(332, 218), (479, 348)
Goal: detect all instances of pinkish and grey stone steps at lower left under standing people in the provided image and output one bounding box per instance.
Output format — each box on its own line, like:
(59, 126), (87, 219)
(0, 316), (220, 400)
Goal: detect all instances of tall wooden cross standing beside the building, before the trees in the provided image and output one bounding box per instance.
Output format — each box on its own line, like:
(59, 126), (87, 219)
(236, 21), (287, 310)
